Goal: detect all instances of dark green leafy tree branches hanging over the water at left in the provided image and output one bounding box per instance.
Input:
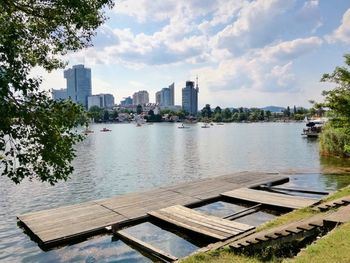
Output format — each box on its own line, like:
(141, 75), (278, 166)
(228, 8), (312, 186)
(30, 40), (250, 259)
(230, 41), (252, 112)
(0, 0), (113, 184)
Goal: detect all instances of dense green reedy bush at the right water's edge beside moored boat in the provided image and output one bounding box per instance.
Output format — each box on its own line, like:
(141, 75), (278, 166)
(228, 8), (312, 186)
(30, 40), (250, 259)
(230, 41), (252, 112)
(320, 125), (350, 157)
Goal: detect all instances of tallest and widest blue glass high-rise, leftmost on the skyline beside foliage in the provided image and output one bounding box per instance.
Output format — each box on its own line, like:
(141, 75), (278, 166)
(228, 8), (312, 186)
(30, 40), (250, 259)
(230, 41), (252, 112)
(64, 65), (91, 108)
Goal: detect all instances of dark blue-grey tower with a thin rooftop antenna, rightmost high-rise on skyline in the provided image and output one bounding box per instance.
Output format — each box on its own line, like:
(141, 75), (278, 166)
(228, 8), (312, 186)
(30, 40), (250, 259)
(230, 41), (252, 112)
(182, 78), (199, 115)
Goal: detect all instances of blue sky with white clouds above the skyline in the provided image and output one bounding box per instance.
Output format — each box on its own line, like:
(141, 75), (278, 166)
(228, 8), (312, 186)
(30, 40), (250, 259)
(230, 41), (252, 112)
(35, 0), (350, 108)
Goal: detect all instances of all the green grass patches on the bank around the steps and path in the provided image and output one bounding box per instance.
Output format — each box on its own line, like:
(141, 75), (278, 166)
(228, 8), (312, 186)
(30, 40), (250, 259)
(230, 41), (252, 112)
(181, 186), (350, 263)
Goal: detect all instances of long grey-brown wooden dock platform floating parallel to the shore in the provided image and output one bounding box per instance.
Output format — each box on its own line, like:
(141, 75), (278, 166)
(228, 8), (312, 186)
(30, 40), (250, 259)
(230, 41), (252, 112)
(17, 172), (289, 248)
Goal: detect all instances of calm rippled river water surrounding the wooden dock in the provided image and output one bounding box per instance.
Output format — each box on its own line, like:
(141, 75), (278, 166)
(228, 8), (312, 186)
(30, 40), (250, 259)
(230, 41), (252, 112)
(0, 123), (350, 262)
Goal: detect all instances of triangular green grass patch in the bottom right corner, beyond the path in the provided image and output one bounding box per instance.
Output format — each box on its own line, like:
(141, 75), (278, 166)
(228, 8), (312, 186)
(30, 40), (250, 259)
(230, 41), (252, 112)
(284, 223), (350, 263)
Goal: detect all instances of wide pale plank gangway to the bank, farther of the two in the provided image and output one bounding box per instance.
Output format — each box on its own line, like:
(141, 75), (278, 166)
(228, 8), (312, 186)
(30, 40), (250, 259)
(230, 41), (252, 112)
(222, 188), (318, 209)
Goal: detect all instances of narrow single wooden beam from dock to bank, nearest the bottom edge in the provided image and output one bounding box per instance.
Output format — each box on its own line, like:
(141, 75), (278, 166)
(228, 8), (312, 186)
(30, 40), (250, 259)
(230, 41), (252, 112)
(114, 230), (178, 262)
